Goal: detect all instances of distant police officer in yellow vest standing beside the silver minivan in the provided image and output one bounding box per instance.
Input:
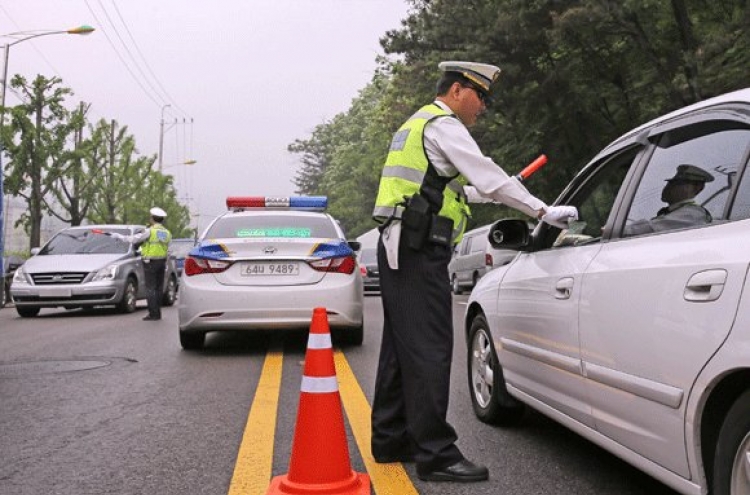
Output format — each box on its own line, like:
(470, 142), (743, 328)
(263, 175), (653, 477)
(125, 207), (172, 321)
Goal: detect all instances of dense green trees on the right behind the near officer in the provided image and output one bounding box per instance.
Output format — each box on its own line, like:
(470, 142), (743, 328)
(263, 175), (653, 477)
(290, 0), (750, 235)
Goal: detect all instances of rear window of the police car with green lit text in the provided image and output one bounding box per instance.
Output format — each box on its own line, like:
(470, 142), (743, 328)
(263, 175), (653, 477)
(205, 215), (339, 239)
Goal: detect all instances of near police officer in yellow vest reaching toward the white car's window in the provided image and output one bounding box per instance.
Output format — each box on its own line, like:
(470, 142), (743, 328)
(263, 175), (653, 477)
(371, 62), (578, 482)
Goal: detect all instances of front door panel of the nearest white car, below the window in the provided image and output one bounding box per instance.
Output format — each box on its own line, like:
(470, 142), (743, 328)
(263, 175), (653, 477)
(495, 244), (601, 427)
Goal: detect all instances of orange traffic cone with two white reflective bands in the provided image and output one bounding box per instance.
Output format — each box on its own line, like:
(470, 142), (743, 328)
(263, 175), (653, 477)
(266, 308), (370, 495)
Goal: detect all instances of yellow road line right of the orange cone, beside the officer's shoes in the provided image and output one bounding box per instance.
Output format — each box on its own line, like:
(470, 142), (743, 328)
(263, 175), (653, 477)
(333, 349), (419, 495)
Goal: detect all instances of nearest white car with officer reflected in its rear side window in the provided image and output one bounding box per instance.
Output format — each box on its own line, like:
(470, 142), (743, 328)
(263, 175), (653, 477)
(465, 89), (750, 495)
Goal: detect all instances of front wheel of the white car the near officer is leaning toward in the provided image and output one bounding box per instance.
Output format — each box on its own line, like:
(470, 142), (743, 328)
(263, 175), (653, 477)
(466, 315), (526, 426)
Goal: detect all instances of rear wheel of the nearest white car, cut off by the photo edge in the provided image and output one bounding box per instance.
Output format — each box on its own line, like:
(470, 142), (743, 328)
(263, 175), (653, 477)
(711, 390), (750, 495)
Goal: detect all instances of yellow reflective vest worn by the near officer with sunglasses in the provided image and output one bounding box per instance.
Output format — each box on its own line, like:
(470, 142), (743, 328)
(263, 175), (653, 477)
(372, 103), (470, 244)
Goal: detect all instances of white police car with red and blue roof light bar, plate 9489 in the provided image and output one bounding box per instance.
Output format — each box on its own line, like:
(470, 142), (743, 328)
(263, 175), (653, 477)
(178, 196), (363, 349)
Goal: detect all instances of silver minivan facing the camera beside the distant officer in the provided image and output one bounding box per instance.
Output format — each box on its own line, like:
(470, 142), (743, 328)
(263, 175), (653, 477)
(10, 225), (178, 317)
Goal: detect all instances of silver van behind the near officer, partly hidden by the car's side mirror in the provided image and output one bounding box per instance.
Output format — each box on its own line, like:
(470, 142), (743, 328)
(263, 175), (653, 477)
(448, 225), (517, 294)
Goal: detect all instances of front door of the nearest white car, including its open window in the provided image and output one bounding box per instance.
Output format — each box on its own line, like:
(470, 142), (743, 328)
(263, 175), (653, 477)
(493, 147), (640, 427)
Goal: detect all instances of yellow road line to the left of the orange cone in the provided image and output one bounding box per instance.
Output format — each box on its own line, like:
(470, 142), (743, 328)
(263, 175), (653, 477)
(229, 349), (284, 495)
